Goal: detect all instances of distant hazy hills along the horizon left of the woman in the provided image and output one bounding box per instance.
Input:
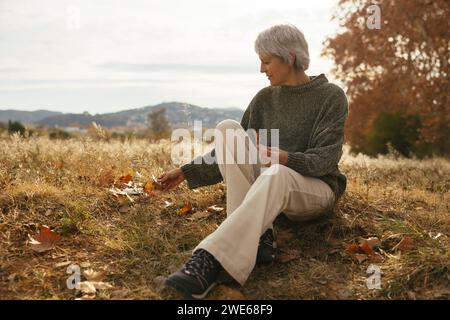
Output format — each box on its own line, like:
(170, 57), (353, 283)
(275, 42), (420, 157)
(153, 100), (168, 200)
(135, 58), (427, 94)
(0, 102), (244, 129)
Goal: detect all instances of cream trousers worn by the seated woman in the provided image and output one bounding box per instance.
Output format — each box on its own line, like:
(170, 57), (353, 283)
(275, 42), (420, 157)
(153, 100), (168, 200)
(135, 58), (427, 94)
(194, 120), (335, 285)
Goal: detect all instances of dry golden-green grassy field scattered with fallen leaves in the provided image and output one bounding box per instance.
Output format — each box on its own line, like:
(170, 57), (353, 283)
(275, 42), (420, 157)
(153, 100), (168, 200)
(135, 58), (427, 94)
(0, 136), (450, 299)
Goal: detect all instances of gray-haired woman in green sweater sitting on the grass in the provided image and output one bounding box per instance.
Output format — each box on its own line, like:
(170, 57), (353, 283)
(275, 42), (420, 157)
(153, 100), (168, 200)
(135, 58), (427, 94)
(159, 25), (348, 299)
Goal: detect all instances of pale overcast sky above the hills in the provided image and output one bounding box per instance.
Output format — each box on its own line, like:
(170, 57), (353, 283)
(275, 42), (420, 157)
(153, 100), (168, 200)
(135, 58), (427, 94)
(0, 0), (339, 114)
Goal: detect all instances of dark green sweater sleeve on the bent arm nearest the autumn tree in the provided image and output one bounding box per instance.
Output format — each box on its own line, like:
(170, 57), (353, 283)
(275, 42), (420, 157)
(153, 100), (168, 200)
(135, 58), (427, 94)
(286, 91), (348, 177)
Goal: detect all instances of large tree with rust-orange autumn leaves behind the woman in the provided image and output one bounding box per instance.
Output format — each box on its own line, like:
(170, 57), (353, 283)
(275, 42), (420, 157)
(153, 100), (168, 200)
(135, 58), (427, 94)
(322, 0), (450, 155)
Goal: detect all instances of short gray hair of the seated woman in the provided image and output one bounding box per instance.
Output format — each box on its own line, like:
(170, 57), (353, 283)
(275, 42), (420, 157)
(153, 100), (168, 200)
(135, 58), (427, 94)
(255, 24), (309, 70)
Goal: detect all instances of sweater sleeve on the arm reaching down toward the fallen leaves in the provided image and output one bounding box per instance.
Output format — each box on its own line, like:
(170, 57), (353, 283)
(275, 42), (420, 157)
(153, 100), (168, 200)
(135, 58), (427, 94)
(181, 104), (251, 189)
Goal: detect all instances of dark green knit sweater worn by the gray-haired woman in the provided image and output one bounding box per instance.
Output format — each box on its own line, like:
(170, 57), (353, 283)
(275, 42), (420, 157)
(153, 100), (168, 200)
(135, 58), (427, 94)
(181, 74), (348, 198)
